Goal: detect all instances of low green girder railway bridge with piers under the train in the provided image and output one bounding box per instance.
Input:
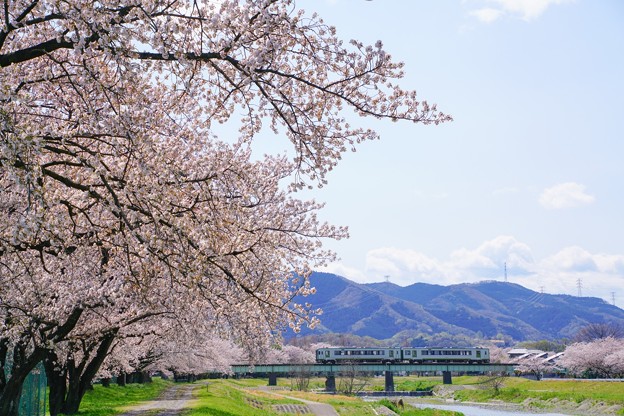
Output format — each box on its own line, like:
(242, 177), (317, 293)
(232, 363), (514, 391)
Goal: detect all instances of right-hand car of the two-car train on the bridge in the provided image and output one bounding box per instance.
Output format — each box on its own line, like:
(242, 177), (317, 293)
(401, 347), (490, 364)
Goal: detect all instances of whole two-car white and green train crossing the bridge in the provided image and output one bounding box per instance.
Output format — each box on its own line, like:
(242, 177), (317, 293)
(316, 347), (490, 364)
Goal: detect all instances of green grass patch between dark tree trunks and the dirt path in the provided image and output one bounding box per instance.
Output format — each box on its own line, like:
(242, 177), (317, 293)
(78, 378), (173, 416)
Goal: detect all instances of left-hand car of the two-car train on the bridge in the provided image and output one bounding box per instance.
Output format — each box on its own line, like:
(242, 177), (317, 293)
(316, 347), (403, 364)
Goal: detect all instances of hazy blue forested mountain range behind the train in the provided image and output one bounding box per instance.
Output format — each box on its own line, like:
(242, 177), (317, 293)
(296, 272), (624, 345)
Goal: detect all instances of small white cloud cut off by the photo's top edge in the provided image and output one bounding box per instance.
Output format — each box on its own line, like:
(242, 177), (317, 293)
(470, 0), (573, 23)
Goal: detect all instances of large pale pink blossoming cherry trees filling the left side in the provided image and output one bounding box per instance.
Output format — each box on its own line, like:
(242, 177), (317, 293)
(0, 0), (450, 416)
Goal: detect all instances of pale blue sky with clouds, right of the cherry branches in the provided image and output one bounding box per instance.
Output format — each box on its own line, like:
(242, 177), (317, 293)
(297, 0), (624, 307)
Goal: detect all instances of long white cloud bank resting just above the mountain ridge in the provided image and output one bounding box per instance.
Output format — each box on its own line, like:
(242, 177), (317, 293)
(328, 236), (624, 307)
